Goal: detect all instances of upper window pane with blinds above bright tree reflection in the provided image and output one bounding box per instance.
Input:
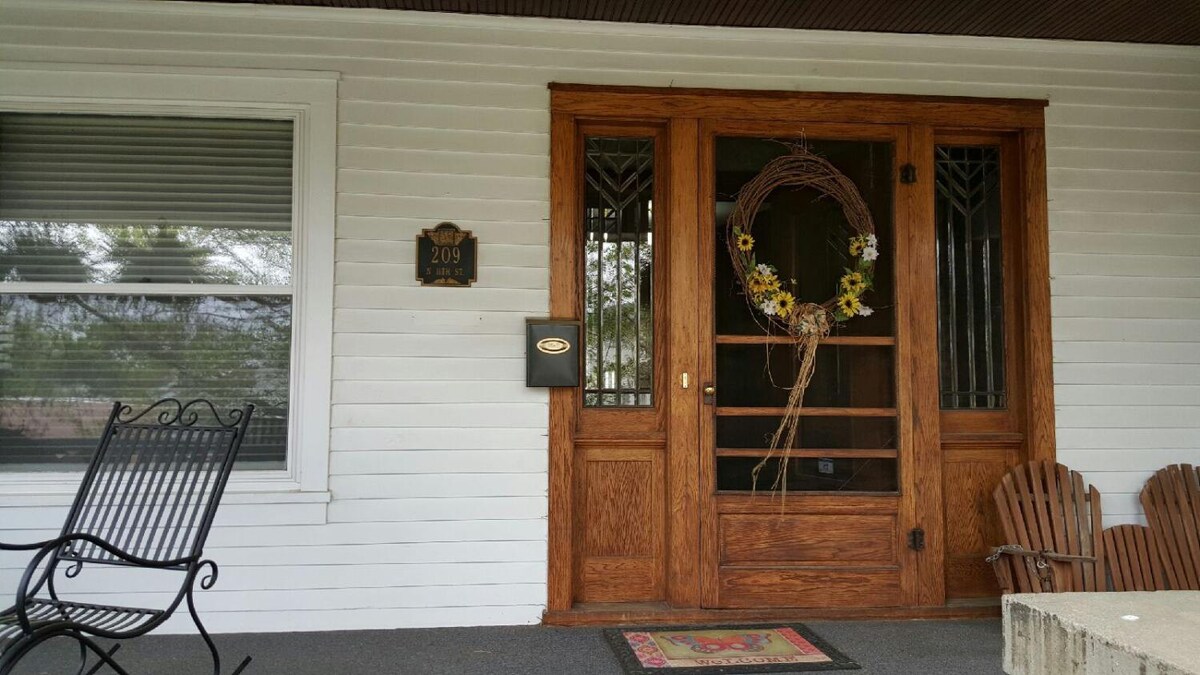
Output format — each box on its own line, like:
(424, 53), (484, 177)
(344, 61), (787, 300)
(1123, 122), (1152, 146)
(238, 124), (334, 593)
(0, 113), (293, 286)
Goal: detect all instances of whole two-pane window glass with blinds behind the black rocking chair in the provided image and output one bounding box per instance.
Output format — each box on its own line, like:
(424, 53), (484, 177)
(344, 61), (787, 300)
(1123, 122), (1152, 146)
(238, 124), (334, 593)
(0, 113), (294, 471)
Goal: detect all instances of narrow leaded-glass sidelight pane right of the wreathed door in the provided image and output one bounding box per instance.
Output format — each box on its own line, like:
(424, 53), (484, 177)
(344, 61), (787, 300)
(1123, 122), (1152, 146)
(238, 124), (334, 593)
(935, 145), (1008, 410)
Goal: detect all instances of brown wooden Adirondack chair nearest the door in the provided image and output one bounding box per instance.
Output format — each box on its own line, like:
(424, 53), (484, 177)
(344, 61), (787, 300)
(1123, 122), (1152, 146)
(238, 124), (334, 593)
(988, 461), (1106, 593)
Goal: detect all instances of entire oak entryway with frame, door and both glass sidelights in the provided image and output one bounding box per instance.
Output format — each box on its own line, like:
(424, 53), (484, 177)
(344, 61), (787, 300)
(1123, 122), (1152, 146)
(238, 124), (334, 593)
(547, 85), (1054, 622)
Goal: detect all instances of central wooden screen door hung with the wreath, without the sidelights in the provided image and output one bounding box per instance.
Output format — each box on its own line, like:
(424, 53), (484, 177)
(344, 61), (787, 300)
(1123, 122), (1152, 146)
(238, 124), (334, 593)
(698, 123), (936, 608)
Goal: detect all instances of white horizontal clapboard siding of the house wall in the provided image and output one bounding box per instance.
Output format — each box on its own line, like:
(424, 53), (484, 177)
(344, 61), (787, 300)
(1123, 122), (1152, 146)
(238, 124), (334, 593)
(0, 0), (1200, 631)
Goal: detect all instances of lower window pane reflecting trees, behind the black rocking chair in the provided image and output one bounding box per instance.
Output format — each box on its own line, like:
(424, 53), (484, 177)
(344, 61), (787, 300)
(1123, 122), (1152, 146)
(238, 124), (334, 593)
(0, 294), (292, 471)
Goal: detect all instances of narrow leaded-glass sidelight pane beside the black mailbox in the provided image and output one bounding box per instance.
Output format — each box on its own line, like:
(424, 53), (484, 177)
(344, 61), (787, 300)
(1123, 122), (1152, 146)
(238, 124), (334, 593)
(582, 137), (654, 407)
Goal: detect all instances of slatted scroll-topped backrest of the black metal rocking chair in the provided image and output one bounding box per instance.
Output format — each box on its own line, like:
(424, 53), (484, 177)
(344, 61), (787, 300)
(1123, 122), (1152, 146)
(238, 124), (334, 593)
(58, 399), (254, 565)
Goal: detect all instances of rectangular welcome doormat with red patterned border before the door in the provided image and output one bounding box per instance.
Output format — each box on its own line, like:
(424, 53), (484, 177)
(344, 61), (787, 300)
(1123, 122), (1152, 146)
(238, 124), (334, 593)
(604, 623), (860, 675)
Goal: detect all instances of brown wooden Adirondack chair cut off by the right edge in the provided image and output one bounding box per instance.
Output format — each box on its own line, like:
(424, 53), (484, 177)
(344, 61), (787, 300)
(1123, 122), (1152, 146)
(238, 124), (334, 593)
(1141, 464), (1200, 591)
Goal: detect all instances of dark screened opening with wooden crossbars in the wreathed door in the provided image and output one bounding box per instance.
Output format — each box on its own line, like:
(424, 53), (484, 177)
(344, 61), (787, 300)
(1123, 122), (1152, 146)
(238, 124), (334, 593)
(713, 138), (899, 492)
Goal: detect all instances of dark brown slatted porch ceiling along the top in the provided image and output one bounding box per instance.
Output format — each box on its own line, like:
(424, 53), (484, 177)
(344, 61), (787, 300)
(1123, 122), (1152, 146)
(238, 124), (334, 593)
(192, 0), (1200, 44)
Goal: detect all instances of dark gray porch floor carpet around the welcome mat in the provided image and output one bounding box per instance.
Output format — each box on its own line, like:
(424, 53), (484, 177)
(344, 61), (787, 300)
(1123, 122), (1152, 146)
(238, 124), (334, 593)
(13, 620), (1003, 675)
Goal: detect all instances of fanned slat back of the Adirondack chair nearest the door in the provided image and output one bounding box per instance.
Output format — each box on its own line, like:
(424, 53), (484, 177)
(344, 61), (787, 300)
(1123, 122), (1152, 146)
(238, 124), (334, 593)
(992, 461), (1105, 593)
